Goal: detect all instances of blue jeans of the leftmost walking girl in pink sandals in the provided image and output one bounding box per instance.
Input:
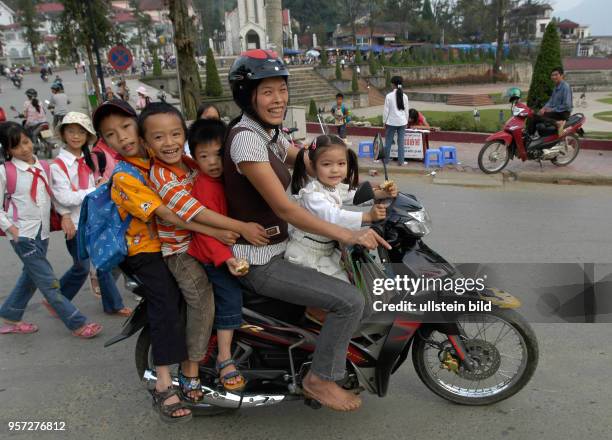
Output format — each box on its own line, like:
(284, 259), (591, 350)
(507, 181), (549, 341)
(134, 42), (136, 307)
(0, 232), (87, 330)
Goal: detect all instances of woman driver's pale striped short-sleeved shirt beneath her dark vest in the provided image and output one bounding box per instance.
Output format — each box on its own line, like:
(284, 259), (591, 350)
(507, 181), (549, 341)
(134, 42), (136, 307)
(226, 115), (289, 266)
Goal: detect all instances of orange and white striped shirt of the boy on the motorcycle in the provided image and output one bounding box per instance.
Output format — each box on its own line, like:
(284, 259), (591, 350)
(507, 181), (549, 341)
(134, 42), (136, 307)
(150, 157), (204, 257)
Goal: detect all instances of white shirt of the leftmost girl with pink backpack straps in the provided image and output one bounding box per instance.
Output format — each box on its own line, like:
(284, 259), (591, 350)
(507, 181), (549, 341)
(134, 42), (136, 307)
(0, 158), (51, 240)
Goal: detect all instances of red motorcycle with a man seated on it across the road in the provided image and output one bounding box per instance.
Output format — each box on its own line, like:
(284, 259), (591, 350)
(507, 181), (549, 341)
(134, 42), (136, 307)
(478, 99), (586, 174)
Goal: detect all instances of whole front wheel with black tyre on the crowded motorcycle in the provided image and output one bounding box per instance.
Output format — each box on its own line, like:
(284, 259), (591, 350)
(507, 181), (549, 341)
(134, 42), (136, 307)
(412, 309), (539, 406)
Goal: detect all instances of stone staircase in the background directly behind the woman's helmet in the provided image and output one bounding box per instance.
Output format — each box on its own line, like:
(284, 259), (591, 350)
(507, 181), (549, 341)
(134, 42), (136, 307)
(200, 67), (338, 108)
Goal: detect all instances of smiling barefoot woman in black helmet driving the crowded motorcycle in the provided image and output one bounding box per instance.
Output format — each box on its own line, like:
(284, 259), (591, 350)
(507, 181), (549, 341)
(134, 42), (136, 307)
(224, 49), (386, 411)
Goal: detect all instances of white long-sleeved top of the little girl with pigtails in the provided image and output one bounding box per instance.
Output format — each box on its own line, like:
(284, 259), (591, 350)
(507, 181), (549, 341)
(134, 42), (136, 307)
(293, 180), (363, 235)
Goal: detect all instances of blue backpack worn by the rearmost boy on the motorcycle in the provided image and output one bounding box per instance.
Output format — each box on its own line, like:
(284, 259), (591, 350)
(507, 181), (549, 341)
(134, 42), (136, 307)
(77, 161), (146, 272)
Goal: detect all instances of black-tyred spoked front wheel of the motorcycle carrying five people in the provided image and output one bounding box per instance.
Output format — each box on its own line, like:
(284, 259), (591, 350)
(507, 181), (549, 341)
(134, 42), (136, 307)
(412, 309), (539, 406)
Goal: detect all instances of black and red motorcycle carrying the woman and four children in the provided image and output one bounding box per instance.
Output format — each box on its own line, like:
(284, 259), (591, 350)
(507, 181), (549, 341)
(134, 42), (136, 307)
(105, 171), (538, 415)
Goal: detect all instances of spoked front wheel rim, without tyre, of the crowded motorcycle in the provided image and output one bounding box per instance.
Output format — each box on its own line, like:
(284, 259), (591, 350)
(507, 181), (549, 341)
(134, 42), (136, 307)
(423, 314), (528, 398)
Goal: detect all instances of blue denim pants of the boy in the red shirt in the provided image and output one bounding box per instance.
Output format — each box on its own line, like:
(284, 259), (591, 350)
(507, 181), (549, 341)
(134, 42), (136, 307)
(202, 264), (242, 330)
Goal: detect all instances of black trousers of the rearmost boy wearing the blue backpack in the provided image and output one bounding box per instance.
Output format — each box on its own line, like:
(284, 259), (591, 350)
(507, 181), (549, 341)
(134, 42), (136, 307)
(120, 252), (187, 365)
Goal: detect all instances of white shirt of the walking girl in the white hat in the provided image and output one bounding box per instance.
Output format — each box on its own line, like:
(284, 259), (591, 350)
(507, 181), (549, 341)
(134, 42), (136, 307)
(51, 148), (96, 226)
